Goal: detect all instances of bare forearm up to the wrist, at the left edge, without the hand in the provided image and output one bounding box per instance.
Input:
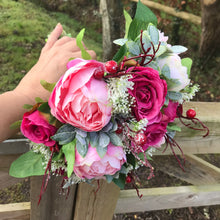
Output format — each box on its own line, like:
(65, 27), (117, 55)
(0, 91), (34, 142)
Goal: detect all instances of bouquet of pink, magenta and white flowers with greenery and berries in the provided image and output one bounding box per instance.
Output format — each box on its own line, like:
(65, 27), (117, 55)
(10, 2), (208, 201)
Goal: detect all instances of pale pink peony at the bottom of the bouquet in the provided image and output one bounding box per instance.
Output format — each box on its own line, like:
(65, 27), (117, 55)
(74, 143), (126, 179)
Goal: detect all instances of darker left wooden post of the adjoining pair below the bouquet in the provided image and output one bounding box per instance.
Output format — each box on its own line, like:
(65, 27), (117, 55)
(30, 176), (76, 220)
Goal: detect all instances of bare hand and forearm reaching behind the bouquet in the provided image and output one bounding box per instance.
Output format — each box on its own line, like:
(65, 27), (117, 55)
(0, 24), (96, 142)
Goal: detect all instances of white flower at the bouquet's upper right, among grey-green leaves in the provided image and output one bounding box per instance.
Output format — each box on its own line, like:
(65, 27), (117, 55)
(157, 53), (190, 92)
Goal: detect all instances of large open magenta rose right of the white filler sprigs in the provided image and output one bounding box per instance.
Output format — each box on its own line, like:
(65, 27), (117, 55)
(129, 67), (167, 123)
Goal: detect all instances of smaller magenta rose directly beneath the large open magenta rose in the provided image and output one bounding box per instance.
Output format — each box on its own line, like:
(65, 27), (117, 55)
(142, 122), (167, 151)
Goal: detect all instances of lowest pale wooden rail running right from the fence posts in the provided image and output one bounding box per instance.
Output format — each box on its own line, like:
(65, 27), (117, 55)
(115, 184), (220, 213)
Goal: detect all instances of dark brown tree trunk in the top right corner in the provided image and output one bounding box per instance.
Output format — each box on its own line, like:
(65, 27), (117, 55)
(200, 0), (220, 60)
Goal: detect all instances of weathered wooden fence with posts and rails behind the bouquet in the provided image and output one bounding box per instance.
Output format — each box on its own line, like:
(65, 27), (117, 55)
(0, 102), (220, 220)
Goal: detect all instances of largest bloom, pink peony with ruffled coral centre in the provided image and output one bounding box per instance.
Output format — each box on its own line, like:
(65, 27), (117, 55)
(49, 59), (112, 131)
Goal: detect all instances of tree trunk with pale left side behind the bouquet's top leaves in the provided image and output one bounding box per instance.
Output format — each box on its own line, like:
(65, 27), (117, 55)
(100, 0), (124, 61)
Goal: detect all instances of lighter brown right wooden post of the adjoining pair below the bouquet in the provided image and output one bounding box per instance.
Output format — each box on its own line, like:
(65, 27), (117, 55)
(74, 180), (120, 220)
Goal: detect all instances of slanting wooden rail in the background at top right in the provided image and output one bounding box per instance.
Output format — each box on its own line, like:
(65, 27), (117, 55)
(132, 0), (201, 25)
